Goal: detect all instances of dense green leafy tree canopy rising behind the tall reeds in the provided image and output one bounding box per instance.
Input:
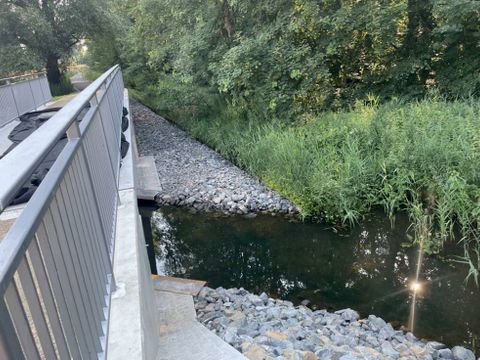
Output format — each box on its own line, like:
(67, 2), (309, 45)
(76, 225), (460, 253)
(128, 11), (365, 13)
(97, 0), (480, 114)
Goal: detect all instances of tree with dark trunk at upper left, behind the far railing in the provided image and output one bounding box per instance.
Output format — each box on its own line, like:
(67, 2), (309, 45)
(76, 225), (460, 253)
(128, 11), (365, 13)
(0, 0), (106, 84)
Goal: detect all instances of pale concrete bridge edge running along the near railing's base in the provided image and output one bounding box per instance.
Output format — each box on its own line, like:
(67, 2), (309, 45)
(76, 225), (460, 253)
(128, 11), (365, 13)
(107, 90), (159, 360)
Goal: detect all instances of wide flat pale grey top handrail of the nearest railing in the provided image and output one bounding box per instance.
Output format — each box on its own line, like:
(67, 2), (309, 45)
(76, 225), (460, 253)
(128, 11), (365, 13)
(0, 65), (119, 212)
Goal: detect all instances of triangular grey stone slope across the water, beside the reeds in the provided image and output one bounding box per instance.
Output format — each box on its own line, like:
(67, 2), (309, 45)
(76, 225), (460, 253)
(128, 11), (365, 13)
(130, 100), (298, 215)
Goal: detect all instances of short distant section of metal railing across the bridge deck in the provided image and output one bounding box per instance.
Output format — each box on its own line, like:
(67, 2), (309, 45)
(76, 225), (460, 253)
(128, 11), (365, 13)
(0, 74), (52, 127)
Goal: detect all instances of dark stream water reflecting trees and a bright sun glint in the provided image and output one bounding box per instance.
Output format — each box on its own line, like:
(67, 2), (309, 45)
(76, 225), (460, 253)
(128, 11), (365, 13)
(152, 209), (480, 352)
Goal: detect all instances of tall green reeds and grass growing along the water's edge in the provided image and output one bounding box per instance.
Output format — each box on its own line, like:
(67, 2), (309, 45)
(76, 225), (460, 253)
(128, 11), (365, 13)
(131, 88), (480, 280)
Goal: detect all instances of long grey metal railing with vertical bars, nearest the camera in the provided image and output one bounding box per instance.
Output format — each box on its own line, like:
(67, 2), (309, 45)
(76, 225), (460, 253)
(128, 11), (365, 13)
(0, 66), (123, 359)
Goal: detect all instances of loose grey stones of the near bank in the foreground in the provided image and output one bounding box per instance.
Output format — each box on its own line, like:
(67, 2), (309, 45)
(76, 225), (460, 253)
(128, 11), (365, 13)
(195, 288), (475, 360)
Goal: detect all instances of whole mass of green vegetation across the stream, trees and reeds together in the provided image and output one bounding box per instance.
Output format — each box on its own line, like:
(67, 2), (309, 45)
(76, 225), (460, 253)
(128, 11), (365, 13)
(89, 0), (480, 276)
